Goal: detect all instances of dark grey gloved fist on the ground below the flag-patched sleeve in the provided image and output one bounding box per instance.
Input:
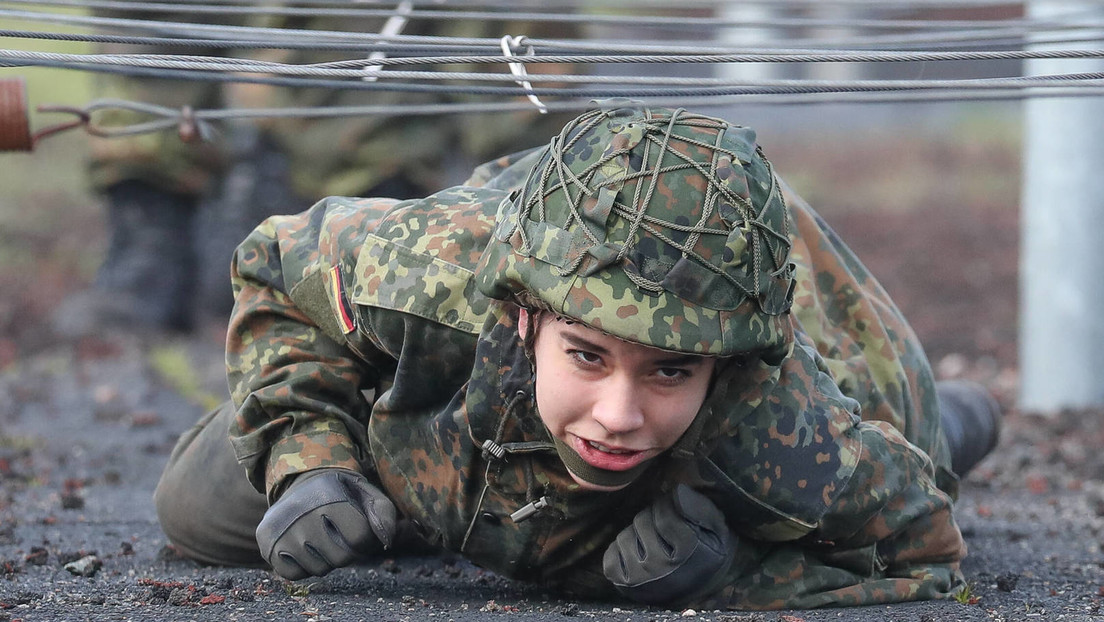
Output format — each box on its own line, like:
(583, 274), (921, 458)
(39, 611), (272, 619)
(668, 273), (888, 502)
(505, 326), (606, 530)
(257, 468), (395, 581)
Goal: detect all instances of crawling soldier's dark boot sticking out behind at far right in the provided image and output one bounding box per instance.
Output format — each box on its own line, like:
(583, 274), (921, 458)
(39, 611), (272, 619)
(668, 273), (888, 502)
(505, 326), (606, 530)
(935, 380), (1000, 477)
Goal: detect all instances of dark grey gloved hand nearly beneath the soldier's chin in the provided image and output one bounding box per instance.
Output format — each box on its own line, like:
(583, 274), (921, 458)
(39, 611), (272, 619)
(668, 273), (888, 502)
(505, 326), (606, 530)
(602, 484), (736, 604)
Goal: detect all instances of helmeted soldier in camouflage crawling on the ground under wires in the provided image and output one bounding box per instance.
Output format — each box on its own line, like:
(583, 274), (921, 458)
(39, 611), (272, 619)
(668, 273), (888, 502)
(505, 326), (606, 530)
(156, 101), (999, 609)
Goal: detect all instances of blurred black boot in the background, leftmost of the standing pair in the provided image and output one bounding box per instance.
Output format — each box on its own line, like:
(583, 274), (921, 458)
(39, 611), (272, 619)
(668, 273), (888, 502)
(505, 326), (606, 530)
(53, 181), (197, 337)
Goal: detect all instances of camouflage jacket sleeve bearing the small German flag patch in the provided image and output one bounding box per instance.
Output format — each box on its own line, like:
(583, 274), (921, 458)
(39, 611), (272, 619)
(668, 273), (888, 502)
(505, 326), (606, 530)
(226, 199), (393, 500)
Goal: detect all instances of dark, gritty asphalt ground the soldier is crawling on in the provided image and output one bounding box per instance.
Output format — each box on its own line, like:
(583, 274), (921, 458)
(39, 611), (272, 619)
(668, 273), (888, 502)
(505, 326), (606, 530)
(0, 334), (1104, 622)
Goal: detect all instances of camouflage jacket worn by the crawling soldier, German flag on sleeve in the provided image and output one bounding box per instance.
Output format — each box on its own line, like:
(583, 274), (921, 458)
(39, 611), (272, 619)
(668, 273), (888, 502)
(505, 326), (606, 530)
(226, 148), (965, 609)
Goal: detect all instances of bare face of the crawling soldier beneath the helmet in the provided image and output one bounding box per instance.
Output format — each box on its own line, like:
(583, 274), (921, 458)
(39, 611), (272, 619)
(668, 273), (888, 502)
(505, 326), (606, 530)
(518, 309), (715, 491)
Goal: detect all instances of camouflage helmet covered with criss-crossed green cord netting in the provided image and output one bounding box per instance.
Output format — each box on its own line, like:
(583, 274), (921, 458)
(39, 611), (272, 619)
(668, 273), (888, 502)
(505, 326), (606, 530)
(476, 101), (794, 358)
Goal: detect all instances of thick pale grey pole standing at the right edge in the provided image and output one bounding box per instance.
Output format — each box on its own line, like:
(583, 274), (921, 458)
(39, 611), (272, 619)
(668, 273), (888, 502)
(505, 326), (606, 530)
(1019, 0), (1104, 412)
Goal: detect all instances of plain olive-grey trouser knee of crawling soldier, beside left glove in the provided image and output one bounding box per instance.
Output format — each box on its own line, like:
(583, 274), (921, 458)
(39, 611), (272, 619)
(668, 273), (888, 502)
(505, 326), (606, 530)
(153, 401), (268, 567)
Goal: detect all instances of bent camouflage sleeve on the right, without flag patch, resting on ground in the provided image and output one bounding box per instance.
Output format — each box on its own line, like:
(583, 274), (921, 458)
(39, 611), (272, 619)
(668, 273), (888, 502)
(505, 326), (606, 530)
(697, 346), (966, 609)
